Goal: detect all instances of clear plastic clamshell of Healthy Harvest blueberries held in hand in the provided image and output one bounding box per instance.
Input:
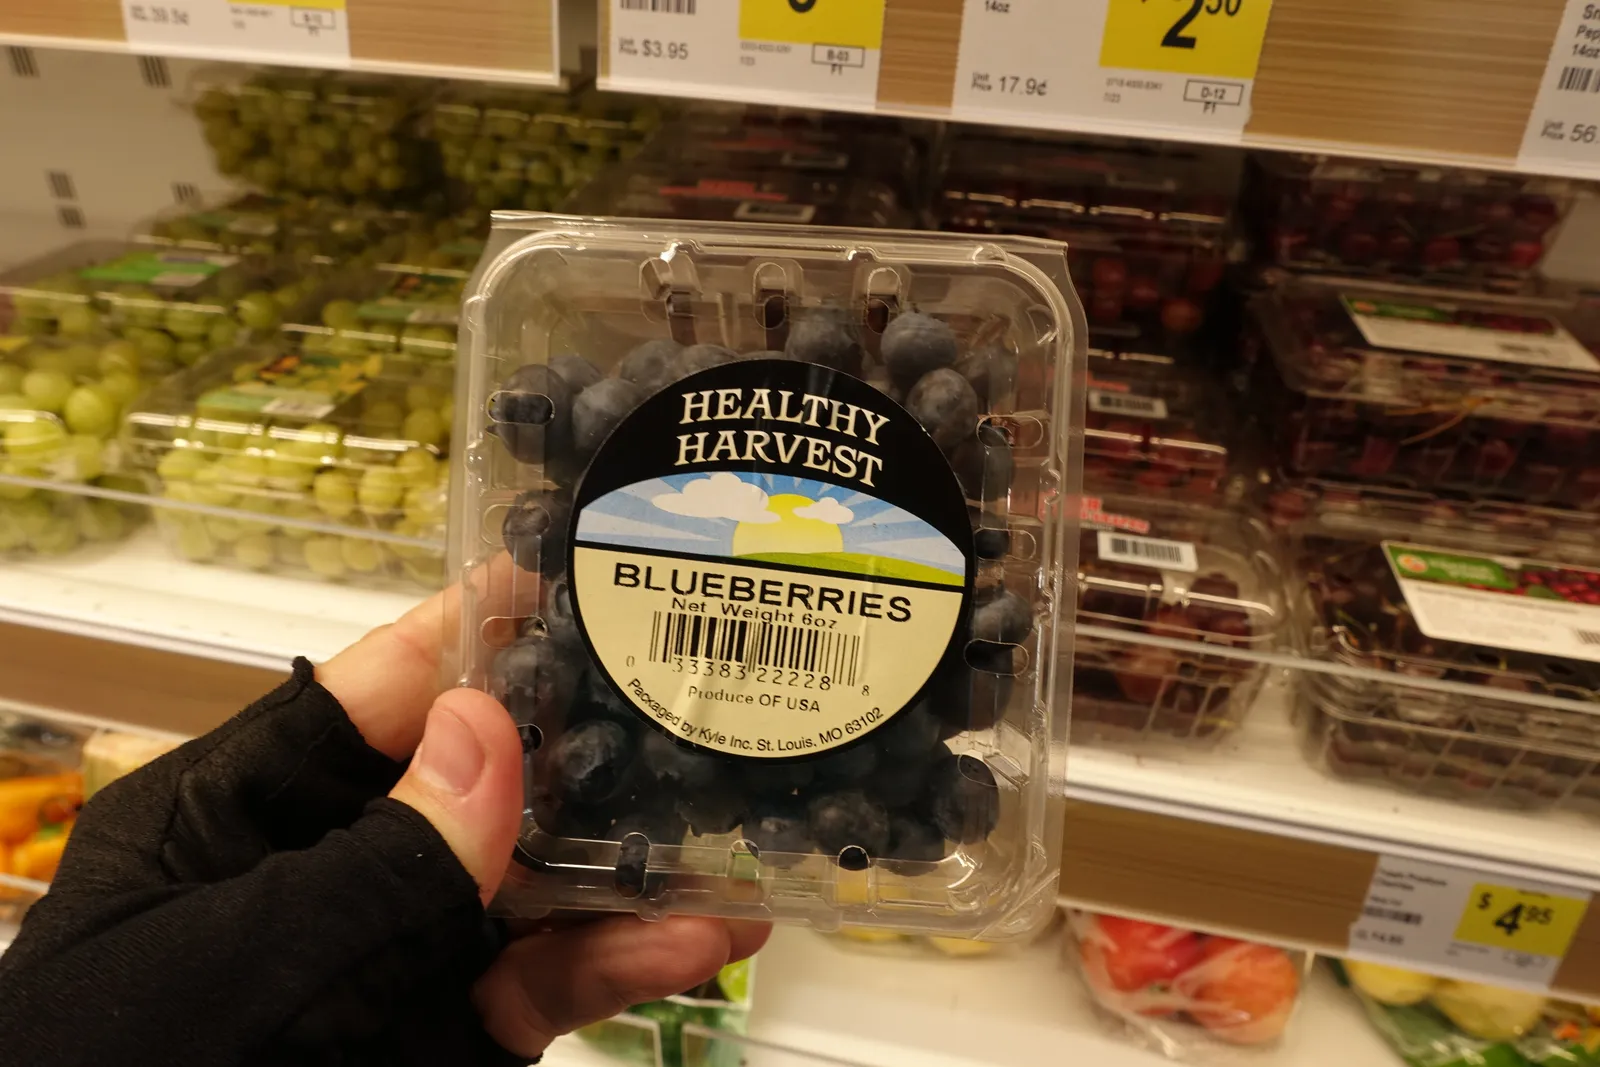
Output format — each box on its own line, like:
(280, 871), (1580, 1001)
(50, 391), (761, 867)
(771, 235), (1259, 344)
(450, 213), (1085, 939)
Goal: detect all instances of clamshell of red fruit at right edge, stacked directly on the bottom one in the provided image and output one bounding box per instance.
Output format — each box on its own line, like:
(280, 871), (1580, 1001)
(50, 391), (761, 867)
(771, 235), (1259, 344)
(1253, 280), (1600, 510)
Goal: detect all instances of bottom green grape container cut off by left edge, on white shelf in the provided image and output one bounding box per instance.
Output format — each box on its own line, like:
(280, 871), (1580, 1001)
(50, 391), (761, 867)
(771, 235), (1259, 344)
(0, 336), (142, 557)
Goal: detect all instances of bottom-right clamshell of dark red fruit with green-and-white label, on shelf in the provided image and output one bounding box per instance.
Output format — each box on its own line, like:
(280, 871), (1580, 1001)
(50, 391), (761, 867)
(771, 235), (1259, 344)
(1294, 510), (1600, 808)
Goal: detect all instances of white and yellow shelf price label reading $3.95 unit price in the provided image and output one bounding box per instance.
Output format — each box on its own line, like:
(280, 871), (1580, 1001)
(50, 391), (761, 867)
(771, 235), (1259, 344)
(600, 0), (886, 110)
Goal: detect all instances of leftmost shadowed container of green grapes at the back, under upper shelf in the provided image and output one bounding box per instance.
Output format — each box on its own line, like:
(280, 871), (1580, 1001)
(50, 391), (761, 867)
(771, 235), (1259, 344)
(190, 66), (435, 202)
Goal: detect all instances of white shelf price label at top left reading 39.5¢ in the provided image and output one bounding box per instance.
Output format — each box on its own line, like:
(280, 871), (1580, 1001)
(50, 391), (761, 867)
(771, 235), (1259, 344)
(122, 0), (350, 67)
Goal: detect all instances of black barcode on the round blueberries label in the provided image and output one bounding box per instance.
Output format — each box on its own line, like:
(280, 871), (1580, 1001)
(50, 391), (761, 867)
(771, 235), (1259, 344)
(650, 611), (861, 685)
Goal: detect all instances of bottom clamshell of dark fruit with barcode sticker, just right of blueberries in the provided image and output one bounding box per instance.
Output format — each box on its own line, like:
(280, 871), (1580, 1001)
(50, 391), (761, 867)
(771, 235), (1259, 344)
(1072, 490), (1288, 744)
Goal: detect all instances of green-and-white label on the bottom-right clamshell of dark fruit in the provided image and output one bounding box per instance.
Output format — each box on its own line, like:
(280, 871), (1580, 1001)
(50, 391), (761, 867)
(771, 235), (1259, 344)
(1384, 541), (1600, 662)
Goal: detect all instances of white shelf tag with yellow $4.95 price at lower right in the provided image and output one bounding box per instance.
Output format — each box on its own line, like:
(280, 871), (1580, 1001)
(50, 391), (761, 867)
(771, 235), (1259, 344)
(1347, 856), (1590, 992)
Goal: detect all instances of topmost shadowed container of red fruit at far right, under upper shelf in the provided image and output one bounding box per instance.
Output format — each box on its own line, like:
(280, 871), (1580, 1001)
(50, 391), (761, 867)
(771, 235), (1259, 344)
(1251, 152), (1579, 285)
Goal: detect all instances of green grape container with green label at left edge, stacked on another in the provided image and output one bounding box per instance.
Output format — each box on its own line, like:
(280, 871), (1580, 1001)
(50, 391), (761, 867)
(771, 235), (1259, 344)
(0, 242), (323, 373)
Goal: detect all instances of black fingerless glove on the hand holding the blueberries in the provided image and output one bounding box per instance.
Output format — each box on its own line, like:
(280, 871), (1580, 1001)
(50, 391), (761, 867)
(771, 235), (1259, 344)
(0, 659), (526, 1067)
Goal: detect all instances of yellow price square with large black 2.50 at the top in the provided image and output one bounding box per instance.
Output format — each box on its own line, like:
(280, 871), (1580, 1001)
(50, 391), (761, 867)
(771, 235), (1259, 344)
(1100, 0), (1272, 80)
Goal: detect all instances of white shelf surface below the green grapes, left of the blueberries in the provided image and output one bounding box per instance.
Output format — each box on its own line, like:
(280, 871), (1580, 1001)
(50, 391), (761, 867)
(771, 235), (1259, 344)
(0, 528), (422, 670)
